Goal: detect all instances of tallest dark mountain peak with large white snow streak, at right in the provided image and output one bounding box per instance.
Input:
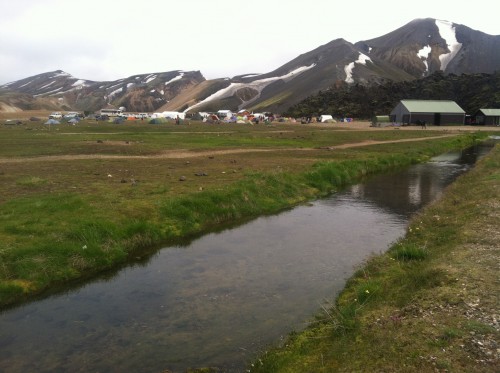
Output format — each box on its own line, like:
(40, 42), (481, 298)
(355, 18), (500, 78)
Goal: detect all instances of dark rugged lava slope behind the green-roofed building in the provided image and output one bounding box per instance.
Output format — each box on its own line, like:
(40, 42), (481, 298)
(282, 70), (500, 119)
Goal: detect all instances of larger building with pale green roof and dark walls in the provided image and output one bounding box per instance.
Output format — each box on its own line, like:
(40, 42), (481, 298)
(391, 100), (465, 126)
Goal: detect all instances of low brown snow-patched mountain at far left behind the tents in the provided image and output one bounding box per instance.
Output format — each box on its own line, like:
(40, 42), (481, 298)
(0, 70), (205, 112)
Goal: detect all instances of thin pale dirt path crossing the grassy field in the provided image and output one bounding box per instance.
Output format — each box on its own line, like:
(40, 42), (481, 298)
(0, 134), (457, 164)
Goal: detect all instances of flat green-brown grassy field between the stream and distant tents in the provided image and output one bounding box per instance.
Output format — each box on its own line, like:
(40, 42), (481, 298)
(0, 117), (494, 305)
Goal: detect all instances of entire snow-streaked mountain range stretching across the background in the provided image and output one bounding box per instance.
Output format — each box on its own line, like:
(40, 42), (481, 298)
(0, 18), (500, 113)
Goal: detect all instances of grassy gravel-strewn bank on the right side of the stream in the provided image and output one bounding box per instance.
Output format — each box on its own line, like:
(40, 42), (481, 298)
(249, 141), (500, 373)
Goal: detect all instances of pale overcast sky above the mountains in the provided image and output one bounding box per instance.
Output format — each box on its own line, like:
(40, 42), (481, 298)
(0, 0), (500, 84)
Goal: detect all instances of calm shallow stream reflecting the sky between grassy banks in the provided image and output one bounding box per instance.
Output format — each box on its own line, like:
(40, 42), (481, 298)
(0, 143), (488, 373)
